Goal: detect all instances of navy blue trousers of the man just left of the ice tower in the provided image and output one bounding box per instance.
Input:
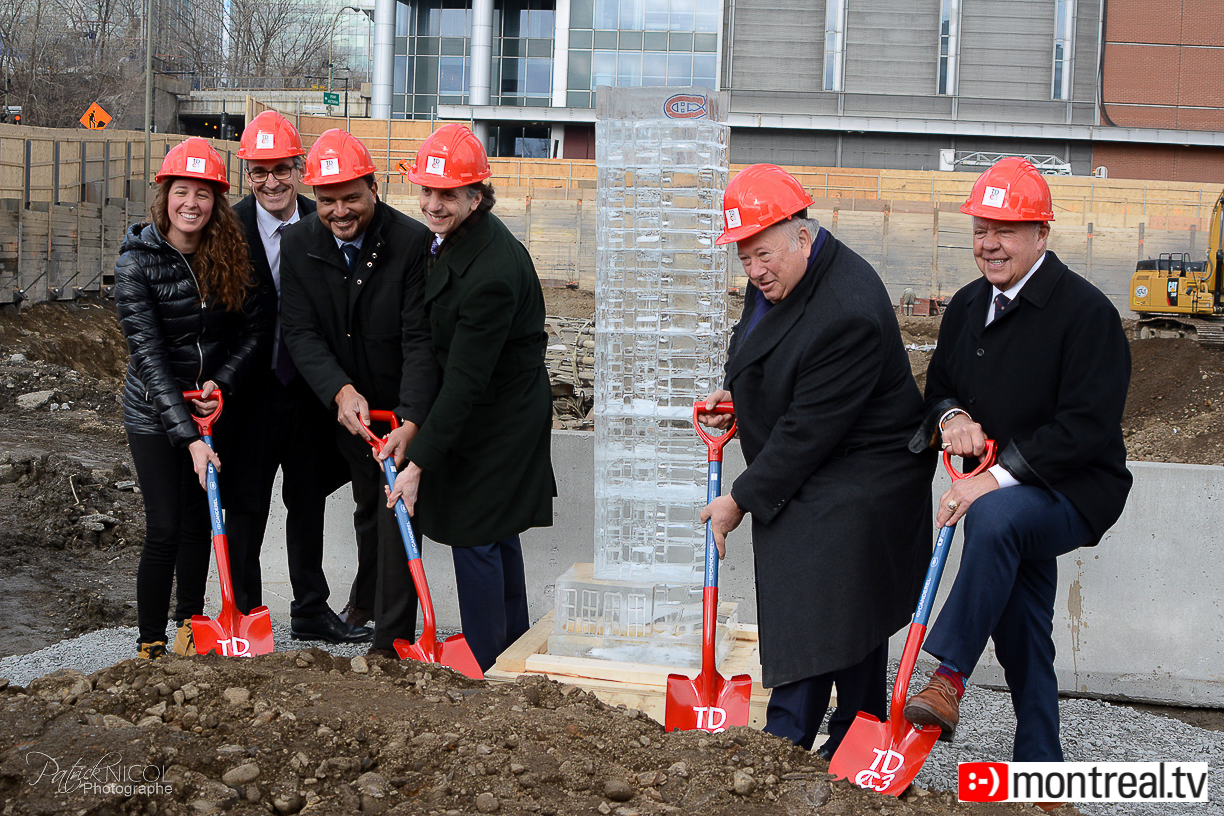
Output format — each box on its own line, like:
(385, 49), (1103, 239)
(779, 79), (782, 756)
(450, 536), (531, 672)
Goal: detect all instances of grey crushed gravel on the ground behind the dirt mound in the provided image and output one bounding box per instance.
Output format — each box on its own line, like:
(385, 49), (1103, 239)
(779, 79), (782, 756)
(0, 623), (1224, 816)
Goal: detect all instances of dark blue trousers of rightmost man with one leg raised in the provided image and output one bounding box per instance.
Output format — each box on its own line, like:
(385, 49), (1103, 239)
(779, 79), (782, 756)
(923, 484), (1094, 762)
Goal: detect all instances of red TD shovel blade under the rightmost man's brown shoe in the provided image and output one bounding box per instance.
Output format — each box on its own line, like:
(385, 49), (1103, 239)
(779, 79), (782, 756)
(829, 712), (939, 796)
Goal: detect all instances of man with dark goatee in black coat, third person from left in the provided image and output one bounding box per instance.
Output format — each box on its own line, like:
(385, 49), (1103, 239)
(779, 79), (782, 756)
(280, 130), (438, 657)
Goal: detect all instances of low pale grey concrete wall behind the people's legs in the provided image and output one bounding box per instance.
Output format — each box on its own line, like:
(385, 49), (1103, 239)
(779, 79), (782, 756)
(241, 432), (1224, 707)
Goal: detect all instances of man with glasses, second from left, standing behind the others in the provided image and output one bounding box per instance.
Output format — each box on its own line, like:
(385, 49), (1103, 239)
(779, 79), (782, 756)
(222, 110), (373, 644)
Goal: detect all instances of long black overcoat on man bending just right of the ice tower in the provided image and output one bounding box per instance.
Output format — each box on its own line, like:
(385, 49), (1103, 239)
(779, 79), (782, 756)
(726, 236), (935, 686)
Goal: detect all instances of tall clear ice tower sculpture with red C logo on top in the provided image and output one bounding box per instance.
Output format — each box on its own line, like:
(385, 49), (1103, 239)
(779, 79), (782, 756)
(548, 87), (734, 666)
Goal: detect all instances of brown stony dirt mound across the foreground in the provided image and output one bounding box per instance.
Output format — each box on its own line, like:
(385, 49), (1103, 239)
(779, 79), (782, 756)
(0, 650), (1076, 816)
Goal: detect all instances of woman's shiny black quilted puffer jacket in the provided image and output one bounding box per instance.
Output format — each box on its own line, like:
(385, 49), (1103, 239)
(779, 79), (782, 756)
(115, 224), (272, 447)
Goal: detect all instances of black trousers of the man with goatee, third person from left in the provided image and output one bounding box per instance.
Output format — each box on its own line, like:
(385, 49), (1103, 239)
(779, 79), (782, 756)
(349, 457), (416, 648)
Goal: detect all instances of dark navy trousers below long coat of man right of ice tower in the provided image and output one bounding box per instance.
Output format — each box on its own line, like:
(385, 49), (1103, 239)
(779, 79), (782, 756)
(763, 641), (889, 752)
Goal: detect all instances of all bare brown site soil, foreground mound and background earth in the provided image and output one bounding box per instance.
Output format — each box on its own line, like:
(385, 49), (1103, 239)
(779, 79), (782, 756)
(0, 290), (1224, 816)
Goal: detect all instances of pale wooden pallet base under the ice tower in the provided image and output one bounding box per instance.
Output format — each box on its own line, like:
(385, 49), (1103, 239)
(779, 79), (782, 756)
(485, 610), (770, 728)
